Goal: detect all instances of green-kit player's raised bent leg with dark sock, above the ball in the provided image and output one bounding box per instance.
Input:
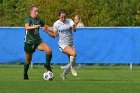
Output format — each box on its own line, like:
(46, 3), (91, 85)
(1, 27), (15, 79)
(37, 42), (52, 71)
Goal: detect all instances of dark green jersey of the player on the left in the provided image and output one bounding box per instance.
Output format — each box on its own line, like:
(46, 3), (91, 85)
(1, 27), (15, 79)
(24, 16), (44, 44)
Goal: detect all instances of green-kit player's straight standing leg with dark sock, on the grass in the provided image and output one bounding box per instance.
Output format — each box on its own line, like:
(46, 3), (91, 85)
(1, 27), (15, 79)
(24, 53), (32, 80)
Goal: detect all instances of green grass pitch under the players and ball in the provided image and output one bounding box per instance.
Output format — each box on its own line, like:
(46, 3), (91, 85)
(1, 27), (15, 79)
(0, 65), (140, 93)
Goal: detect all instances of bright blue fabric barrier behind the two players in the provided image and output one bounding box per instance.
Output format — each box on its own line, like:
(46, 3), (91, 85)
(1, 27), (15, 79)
(0, 27), (140, 64)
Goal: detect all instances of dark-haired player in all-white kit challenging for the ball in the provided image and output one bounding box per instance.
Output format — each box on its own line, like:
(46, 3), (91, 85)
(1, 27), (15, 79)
(53, 9), (77, 80)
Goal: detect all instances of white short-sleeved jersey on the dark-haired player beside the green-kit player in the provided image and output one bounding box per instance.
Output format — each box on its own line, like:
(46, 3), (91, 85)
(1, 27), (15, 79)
(53, 19), (74, 46)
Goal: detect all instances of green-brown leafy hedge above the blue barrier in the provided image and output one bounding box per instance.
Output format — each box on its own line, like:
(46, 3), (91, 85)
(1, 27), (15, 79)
(0, 0), (140, 27)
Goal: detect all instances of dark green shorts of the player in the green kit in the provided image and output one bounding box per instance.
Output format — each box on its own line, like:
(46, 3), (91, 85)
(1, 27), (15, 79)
(24, 41), (42, 54)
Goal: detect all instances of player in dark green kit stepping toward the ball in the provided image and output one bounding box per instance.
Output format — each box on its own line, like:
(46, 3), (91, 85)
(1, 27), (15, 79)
(24, 5), (55, 80)
